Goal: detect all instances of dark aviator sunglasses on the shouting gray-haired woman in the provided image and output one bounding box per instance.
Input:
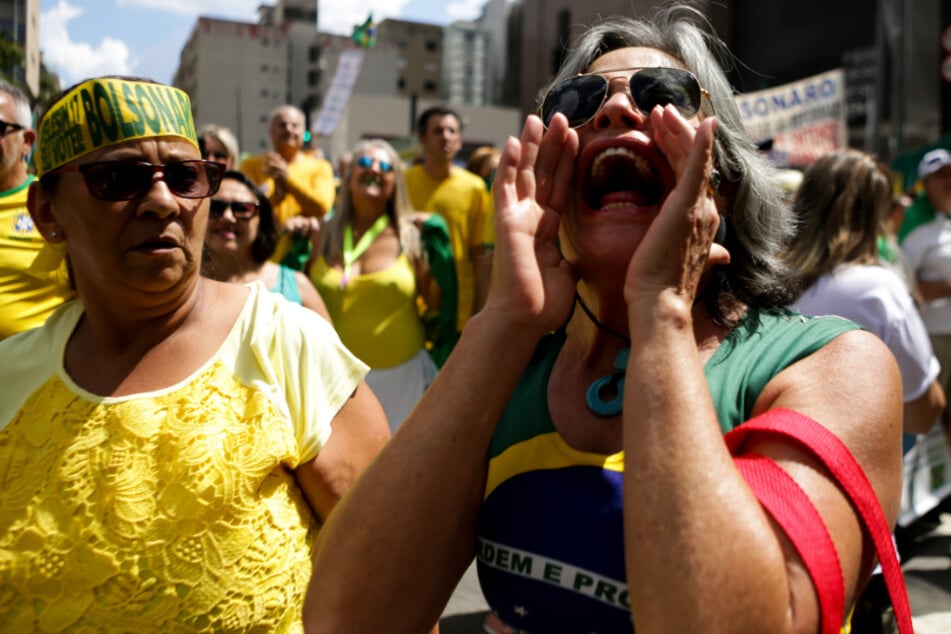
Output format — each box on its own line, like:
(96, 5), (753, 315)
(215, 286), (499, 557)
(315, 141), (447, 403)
(538, 67), (710, 128)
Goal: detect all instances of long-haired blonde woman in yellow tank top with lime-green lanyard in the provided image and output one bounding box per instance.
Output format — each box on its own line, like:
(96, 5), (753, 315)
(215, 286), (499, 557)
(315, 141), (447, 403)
(309, 139), (454, 431)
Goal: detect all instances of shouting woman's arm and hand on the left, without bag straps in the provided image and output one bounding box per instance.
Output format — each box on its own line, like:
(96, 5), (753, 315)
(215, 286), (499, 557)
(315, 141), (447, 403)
(304, 117), (577, 633)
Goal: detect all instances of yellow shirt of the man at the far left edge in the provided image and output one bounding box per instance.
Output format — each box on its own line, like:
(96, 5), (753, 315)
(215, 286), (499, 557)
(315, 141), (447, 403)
(0, 176), (73, 339)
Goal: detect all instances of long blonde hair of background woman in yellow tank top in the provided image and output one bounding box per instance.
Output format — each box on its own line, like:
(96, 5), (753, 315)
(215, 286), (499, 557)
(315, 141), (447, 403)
(320, 139), (420, 262)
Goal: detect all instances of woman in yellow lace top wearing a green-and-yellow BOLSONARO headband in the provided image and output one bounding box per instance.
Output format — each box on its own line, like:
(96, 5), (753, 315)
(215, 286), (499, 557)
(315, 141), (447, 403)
(0, 77), (389, 632)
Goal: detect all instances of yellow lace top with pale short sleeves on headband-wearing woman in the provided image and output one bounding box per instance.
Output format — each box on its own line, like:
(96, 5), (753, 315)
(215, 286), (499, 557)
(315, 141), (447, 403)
(0, 284), (366, 632)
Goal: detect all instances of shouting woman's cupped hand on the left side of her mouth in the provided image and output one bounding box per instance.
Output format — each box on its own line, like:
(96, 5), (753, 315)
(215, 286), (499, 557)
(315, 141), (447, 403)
(483, 115), (578, 334)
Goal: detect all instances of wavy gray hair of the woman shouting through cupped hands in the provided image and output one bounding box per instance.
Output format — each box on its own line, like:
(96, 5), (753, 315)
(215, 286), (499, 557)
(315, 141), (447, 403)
(544, 5), (798, 325)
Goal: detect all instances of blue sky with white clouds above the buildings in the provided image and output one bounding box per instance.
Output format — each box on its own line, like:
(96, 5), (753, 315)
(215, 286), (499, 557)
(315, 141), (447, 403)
(40, 0), (485, 88)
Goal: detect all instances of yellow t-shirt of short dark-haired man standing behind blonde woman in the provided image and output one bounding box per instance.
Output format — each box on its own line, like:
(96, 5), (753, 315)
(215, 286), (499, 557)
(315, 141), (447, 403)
(406, 165), (488, 330)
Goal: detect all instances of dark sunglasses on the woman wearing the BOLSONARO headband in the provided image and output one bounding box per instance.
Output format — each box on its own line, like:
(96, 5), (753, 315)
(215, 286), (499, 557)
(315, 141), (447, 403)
(58, 160), (225, 200)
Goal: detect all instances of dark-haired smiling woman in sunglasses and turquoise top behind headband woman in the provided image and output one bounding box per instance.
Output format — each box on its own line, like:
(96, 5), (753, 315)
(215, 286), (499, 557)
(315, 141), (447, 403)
(202, 171), (330, 319)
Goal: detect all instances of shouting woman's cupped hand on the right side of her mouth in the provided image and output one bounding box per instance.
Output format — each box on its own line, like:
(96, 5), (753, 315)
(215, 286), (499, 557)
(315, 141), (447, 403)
(624, 106), (730, 305)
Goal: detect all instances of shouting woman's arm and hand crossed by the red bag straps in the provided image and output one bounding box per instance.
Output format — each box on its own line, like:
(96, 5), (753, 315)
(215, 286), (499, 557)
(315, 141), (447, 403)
(624, 107), (901, 632)
